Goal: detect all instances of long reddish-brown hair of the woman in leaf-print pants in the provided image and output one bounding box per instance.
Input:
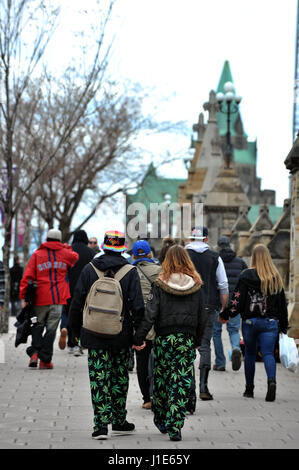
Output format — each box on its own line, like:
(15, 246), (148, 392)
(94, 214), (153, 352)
(159, 245), (203, 285)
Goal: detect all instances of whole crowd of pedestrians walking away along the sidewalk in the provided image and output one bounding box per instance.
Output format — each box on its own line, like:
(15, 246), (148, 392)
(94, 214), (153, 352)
(8, 227), (288, 441)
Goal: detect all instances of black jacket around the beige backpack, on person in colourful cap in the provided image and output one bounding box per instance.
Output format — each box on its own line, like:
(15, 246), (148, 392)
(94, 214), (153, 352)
(68, 254), (144, 349)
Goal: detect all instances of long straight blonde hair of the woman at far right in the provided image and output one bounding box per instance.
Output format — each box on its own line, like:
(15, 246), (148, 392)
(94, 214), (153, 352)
(251, 243), (283, 295)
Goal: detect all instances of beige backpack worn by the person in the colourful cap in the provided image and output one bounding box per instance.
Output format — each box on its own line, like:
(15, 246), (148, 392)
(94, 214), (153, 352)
(83, 263), (134, 336)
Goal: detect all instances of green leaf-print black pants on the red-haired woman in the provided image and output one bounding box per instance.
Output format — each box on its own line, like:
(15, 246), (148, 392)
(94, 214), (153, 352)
(152, 333), (196, 437)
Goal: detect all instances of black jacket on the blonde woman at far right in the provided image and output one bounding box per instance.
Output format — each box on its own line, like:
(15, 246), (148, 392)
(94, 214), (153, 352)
(220, 269), (288, 333)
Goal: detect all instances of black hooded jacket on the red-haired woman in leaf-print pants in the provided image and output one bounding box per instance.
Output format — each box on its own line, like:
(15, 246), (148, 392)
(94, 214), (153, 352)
(134, 278), (205, 346)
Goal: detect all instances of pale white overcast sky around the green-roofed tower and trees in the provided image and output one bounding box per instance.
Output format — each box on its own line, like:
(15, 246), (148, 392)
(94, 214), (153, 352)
(11, 0), (297, 248)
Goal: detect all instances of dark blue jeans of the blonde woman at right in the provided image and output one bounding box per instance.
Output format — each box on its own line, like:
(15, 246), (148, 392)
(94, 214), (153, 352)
(242, 318), (279, 385)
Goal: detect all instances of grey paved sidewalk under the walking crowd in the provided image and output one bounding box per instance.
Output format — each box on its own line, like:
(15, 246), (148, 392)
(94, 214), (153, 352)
(0, 319), (299, 451)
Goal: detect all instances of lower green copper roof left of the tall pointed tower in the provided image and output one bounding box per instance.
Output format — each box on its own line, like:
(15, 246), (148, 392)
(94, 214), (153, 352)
(127, 164), (186, 209)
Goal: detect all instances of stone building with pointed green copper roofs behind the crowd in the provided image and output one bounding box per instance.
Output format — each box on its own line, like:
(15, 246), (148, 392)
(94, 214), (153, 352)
(127, 61), (290, 272)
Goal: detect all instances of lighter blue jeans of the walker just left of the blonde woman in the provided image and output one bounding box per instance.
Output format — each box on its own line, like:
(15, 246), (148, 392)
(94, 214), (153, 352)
(213, 312), (241, 367)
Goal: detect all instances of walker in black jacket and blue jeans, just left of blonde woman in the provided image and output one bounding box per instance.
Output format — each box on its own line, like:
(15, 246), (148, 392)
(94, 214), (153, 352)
(212, 236), (248, 371)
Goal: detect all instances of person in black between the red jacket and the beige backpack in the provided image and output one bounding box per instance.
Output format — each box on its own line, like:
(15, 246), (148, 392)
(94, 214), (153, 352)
(58, 230), (95, 356)
